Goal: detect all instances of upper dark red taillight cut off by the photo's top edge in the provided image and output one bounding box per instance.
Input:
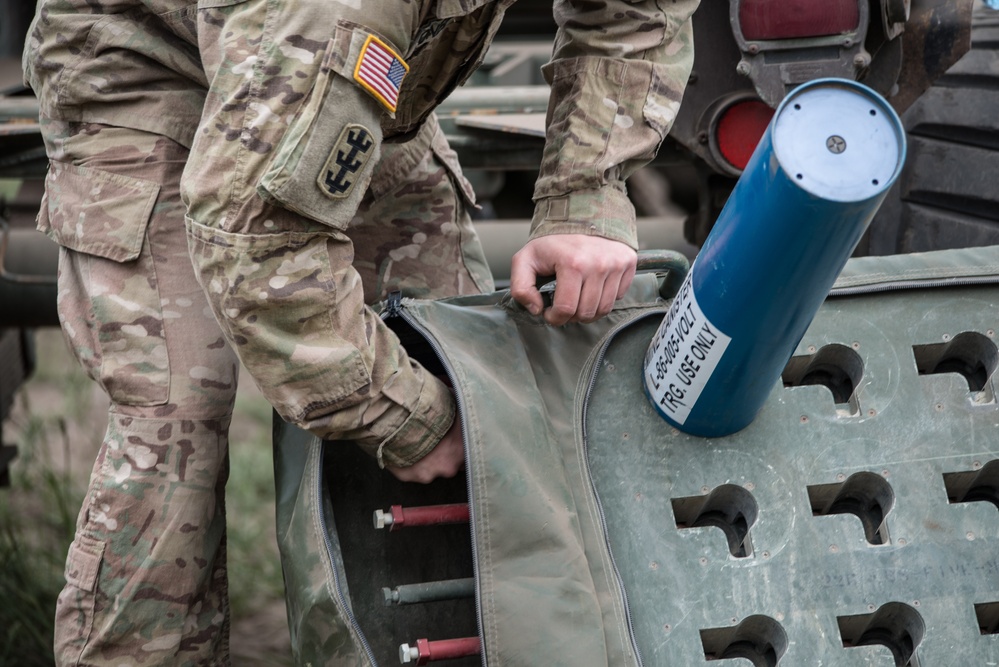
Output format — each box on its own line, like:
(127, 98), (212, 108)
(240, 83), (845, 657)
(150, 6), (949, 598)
(739, 0), (860, 41)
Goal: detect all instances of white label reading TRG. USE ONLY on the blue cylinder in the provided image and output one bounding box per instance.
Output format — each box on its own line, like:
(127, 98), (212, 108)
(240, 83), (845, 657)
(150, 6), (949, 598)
(644, 270), (732, 425)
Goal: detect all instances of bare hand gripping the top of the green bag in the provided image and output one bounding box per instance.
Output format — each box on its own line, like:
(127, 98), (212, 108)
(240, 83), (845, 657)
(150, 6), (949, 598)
(510, 234), (638, 326)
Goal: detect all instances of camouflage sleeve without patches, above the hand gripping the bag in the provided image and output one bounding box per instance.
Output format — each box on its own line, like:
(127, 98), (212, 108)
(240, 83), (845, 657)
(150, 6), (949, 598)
(531, 0), (698, 248)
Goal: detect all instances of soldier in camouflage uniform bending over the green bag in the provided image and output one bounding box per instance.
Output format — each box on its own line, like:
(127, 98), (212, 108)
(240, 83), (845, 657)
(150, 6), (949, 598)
(25, 0), (697, 665)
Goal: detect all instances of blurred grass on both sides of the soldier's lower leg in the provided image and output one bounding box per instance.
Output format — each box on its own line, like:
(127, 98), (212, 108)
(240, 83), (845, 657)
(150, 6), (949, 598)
(0, 329), (292, 667)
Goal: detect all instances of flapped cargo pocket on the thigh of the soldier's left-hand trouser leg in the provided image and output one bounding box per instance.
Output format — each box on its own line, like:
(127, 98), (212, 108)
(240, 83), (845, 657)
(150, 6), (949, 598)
(38, 162), (170, 406)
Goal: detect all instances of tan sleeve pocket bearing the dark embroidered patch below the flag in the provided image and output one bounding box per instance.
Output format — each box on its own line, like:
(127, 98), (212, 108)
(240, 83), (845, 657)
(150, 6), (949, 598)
(257, 21), (401, 231)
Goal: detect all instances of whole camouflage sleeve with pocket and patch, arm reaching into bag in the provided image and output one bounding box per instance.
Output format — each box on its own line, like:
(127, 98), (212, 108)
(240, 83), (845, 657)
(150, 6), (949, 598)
(181, 0), (468, 467)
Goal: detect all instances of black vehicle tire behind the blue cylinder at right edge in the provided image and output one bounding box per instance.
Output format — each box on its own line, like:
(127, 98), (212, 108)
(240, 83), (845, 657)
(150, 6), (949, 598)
(858, 4), (999, 255)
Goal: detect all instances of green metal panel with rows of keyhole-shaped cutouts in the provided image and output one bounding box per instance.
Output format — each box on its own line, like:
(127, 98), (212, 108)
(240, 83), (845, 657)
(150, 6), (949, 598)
(585, 251), (999, 667)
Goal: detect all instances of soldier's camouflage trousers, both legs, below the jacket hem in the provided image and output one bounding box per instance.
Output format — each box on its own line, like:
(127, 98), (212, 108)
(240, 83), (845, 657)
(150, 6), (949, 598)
(39, 119), (490, 667)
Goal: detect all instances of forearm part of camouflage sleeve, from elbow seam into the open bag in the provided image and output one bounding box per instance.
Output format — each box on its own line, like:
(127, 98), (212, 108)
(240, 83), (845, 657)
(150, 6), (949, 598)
(188, 215), (455, 466)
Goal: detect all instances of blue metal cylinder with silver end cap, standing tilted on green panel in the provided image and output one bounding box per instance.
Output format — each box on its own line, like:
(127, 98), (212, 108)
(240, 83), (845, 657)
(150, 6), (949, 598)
(643, 79), (905, 437)
